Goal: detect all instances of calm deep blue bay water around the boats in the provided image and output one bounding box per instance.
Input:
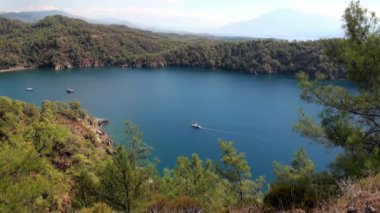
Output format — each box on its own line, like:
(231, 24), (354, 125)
(0, 67), (337, 181)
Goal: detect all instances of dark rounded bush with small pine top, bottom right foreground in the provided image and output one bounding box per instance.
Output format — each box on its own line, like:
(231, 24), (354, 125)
(264, 148), (337, 210)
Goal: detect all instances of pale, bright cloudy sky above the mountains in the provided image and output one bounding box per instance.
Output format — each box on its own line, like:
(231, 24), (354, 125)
(0, 0), (380, 31)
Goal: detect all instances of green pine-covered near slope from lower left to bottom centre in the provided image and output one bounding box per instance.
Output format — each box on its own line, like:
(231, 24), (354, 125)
(0, 97), (264, 212)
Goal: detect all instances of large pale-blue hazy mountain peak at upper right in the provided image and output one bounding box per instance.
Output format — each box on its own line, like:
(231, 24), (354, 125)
(213, 9), (343, 40)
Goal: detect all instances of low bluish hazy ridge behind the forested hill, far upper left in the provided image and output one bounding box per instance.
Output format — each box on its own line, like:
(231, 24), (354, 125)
(0, 10), (75, 23)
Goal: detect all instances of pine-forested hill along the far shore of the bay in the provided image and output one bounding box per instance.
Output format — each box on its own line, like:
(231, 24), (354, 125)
(0, 16), (342, 77)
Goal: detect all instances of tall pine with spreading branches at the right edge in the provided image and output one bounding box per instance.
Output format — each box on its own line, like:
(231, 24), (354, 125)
(295, 2), (380, 177)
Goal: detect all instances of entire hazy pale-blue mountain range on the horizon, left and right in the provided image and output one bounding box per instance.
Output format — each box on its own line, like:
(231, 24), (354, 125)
(0, 9), (343, 40)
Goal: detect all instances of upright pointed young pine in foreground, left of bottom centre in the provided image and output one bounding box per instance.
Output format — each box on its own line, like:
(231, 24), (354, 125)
(99, 122), (156, 212)
